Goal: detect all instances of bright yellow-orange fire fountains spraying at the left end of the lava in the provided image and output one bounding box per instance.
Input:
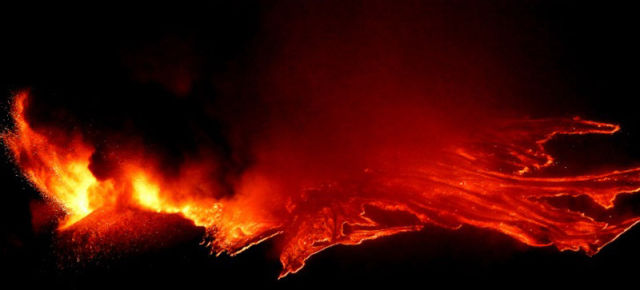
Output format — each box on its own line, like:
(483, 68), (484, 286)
(2, 92), (278, 246)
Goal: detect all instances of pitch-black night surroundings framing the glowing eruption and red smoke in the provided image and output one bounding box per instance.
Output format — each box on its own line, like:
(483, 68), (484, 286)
(0, 1), (640, 288)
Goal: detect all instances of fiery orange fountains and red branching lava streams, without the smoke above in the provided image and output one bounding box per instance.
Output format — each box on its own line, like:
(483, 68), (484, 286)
(2, 92), (640, 277)
